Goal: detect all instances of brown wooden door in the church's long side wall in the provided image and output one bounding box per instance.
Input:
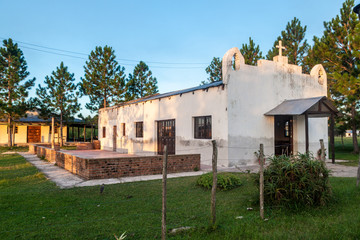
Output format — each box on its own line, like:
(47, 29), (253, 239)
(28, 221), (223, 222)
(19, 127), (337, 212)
(157, 119), (175, 155)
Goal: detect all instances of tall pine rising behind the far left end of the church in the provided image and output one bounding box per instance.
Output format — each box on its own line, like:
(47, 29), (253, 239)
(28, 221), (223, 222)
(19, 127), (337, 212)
(81, 46), (126, 112)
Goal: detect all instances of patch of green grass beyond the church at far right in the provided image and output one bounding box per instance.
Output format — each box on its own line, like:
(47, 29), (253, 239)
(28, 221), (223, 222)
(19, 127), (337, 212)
(329, 137), (360, 166)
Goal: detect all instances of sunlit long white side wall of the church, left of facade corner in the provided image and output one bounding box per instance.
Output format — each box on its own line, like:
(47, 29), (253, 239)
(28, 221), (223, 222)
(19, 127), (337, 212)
(99, 86), (228, 166)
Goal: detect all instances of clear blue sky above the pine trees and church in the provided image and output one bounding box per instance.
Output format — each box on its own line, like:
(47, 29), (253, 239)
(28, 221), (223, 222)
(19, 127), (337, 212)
(0, 0), (348, 115)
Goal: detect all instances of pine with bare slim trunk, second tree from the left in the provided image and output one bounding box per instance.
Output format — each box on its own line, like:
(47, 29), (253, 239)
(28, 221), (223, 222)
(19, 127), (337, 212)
(36, 62), (80, 146)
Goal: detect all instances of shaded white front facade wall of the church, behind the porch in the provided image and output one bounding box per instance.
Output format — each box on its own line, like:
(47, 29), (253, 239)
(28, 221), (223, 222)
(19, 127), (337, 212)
(227, 57), (328, 166)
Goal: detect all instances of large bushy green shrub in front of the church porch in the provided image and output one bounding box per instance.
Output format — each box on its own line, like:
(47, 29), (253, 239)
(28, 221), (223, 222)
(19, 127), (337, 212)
(257, 154), (332, 206)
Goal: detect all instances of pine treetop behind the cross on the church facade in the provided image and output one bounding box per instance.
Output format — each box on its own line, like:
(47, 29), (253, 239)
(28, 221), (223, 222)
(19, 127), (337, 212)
(266, 17), (309, 65)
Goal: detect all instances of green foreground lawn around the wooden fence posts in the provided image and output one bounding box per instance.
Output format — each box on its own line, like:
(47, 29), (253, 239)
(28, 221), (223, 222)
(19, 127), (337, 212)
(0, 155), (360, 239)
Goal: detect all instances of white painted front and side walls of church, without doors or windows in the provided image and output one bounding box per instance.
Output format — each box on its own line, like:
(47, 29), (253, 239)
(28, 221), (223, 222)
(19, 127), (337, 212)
(99, 49), (328, 166)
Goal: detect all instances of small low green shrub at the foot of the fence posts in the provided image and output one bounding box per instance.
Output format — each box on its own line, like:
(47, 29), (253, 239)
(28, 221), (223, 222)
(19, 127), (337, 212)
(196, 172), (241, 191)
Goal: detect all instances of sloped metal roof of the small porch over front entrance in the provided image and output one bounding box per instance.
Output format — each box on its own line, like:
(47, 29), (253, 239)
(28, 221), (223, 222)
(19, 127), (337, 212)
(265, 96), (339, 116)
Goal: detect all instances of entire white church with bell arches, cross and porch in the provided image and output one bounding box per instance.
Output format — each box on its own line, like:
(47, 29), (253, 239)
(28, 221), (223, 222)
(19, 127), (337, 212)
(99, 44), (338, 167)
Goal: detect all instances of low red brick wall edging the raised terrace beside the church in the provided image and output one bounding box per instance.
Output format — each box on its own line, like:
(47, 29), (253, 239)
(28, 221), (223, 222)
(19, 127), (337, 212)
(56, 152), (200, 179)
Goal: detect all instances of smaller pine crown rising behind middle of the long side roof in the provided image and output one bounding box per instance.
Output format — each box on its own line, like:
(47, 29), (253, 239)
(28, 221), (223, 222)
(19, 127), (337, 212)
(125, 61), (158, 101)
